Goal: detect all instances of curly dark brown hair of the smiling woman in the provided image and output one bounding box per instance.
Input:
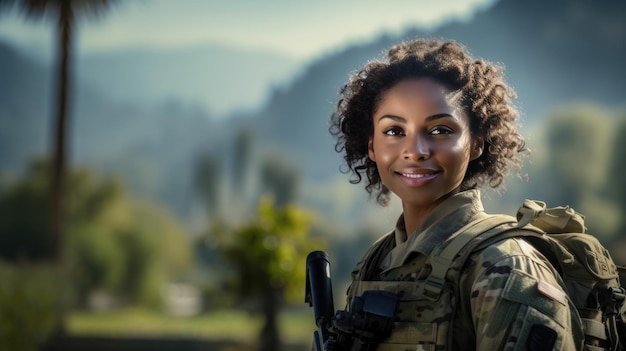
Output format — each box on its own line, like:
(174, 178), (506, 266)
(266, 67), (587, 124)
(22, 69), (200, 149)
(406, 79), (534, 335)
(329, 38), (528, 205)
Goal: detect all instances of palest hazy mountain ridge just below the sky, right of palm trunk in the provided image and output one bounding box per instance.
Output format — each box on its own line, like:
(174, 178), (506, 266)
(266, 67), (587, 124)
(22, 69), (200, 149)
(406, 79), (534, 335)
(77, 44), (300, 116)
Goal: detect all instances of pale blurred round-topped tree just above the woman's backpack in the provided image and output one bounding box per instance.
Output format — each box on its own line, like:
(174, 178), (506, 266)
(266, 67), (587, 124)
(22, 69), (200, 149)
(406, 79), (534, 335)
(531, 103), (624, 244)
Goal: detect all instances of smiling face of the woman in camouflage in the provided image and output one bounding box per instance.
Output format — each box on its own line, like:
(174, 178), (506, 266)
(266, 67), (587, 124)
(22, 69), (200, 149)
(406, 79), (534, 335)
(369, 78), (482, 207)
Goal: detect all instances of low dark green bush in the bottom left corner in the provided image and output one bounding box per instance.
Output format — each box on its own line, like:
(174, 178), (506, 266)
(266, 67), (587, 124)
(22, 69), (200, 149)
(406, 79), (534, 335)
(0, 261), (67, 351)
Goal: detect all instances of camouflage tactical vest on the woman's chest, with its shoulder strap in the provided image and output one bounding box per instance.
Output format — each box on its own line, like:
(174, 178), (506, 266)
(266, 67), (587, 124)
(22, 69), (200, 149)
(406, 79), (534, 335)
(348, 216), (572, 351)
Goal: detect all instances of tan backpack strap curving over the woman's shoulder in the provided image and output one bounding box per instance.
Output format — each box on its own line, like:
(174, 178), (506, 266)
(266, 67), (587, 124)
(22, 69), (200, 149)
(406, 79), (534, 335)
(423, 215), (543, 300)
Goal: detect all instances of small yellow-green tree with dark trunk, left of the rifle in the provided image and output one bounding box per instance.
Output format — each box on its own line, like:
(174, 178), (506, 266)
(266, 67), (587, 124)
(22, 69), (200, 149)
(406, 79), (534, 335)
(214, 197), (322, 351)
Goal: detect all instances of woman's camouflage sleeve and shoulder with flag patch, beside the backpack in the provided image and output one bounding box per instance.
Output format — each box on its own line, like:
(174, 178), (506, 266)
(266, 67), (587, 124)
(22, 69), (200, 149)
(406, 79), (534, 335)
(459, 237), (583, 350)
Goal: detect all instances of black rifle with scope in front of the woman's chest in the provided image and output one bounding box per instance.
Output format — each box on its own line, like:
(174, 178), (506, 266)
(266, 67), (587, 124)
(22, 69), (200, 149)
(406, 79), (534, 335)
(304, 251), (399, 351)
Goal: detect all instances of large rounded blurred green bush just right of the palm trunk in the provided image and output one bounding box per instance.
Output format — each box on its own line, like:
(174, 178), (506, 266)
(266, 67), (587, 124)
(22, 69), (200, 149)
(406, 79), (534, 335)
(68, 172), (192, 307)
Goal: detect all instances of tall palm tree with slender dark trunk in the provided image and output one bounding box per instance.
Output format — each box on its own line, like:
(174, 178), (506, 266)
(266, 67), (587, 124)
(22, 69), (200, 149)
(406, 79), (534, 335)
(0, 0), (115, 261)
